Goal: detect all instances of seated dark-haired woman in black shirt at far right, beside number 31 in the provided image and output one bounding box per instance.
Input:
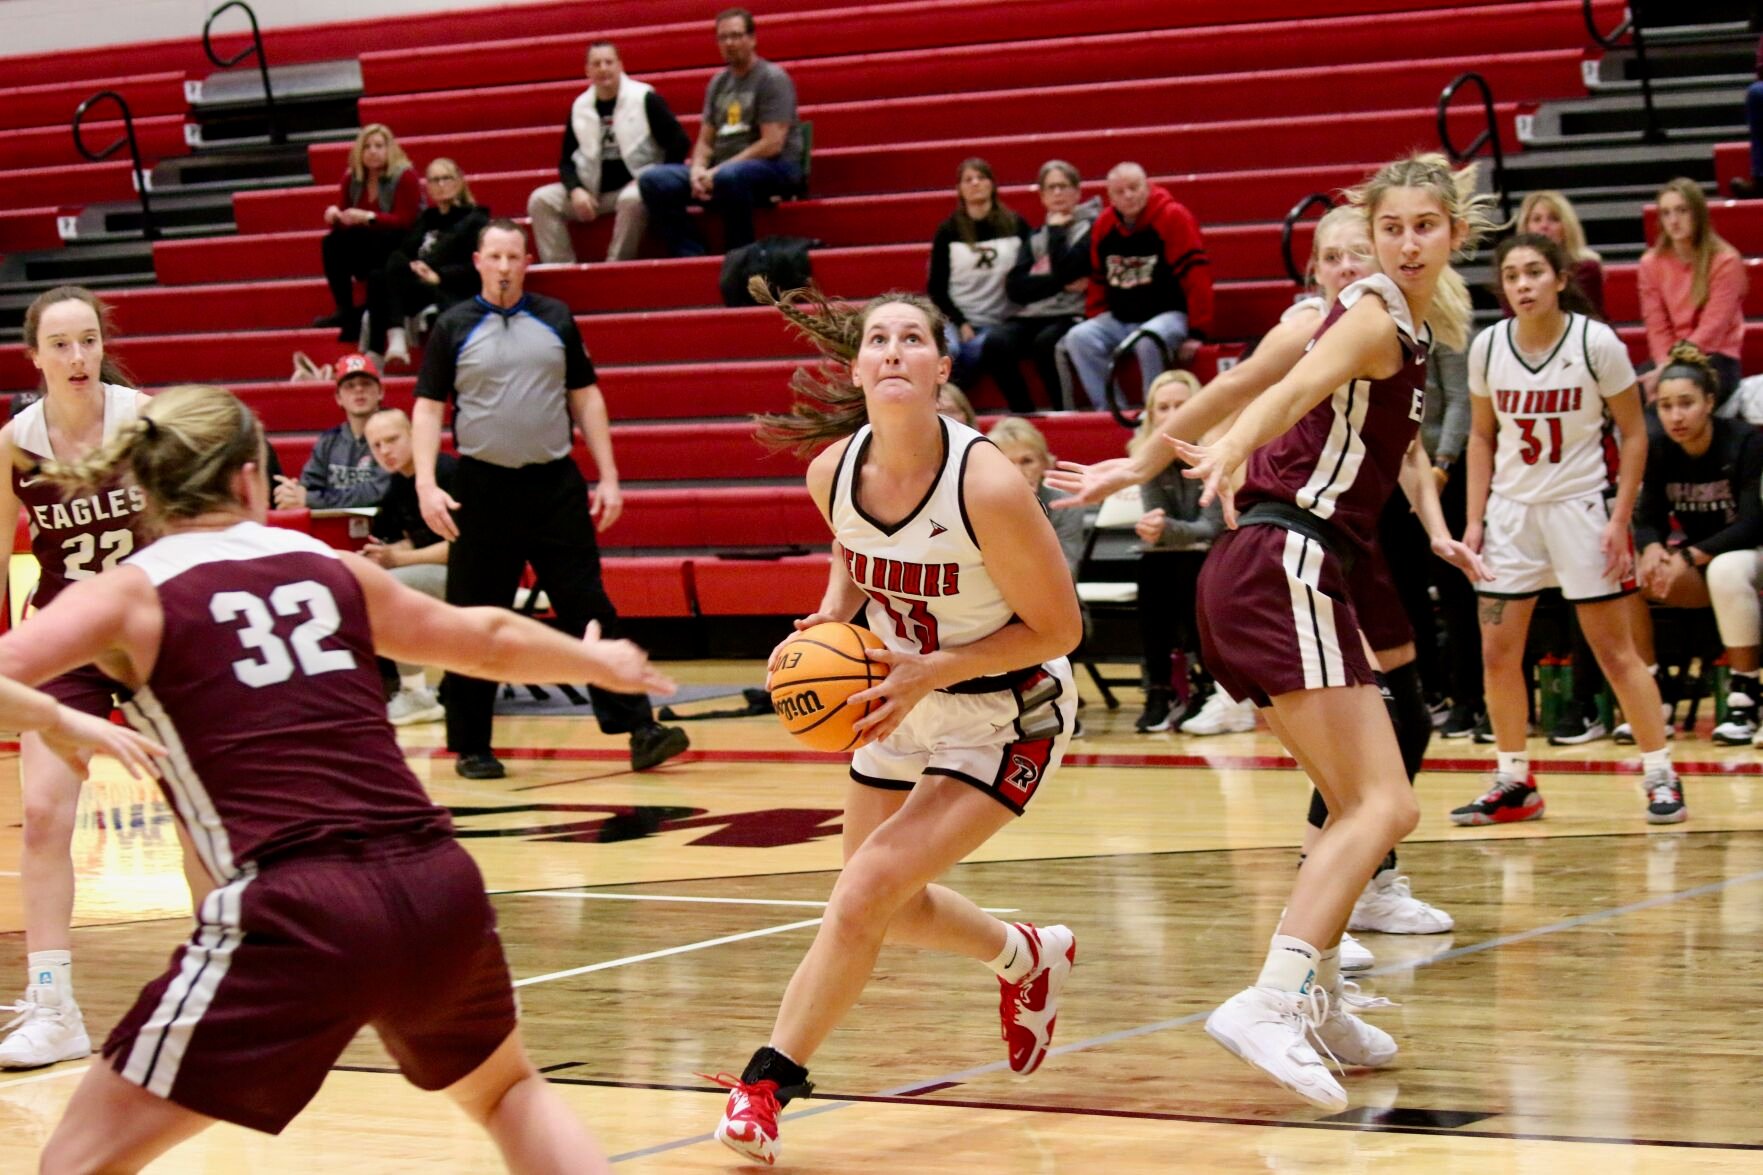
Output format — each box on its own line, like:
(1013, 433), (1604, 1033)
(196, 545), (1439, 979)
(1634, 344), (1763, 746)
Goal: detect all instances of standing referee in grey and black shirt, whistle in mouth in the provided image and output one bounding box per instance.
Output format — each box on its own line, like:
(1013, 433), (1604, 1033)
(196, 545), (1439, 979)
(411, 219), (688, 780)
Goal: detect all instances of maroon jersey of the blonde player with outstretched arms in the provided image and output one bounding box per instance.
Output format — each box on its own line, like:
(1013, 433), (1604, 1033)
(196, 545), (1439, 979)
(1236, 273), (1432, 547)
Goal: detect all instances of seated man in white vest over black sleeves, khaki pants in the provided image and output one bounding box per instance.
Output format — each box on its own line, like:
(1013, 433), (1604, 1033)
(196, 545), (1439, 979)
(527, 41), (691, 265)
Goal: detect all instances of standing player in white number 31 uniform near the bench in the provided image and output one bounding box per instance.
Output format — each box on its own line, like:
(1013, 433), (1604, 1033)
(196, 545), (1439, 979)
(1451, 233), (1687, 824)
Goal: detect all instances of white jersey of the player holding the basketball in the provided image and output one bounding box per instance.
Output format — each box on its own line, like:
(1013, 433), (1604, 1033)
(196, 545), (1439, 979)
(832, 416), (1015, 653)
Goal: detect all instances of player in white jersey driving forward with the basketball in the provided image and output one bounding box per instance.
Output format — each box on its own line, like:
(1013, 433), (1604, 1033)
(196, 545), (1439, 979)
(716, 281), (1082, 1164)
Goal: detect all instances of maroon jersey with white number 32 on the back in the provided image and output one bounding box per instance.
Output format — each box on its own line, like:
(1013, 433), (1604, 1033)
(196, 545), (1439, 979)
(123, 522), (451, 882)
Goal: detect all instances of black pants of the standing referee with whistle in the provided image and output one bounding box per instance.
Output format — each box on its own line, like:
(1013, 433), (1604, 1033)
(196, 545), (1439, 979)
(441, 457), (654, 755)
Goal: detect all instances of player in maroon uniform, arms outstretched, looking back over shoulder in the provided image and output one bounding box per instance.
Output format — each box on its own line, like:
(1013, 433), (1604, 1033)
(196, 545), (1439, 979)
(1176, 155), (1486, 1110)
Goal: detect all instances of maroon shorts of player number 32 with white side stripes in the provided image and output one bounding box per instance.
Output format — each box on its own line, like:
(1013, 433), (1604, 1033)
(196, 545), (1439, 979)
(104, 838), (515, 1134)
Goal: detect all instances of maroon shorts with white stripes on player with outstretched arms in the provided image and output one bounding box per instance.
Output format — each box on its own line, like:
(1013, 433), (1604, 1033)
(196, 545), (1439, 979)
(1199, 524), (1373, 706)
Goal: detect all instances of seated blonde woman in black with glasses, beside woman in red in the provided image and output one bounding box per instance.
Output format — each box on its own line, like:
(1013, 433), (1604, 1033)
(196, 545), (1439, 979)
(367, 159), (490, 367)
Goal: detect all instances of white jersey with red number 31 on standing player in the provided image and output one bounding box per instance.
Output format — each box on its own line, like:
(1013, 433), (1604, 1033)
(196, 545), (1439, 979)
(1469, 314), (1634, 503)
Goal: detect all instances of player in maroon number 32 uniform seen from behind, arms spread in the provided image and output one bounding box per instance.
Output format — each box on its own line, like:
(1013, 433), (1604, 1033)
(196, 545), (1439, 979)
(0, 386), (672, 1171)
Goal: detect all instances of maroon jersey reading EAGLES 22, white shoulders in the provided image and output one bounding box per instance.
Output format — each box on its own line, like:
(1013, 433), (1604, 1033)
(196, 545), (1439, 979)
(12, 383), (146, 609)
